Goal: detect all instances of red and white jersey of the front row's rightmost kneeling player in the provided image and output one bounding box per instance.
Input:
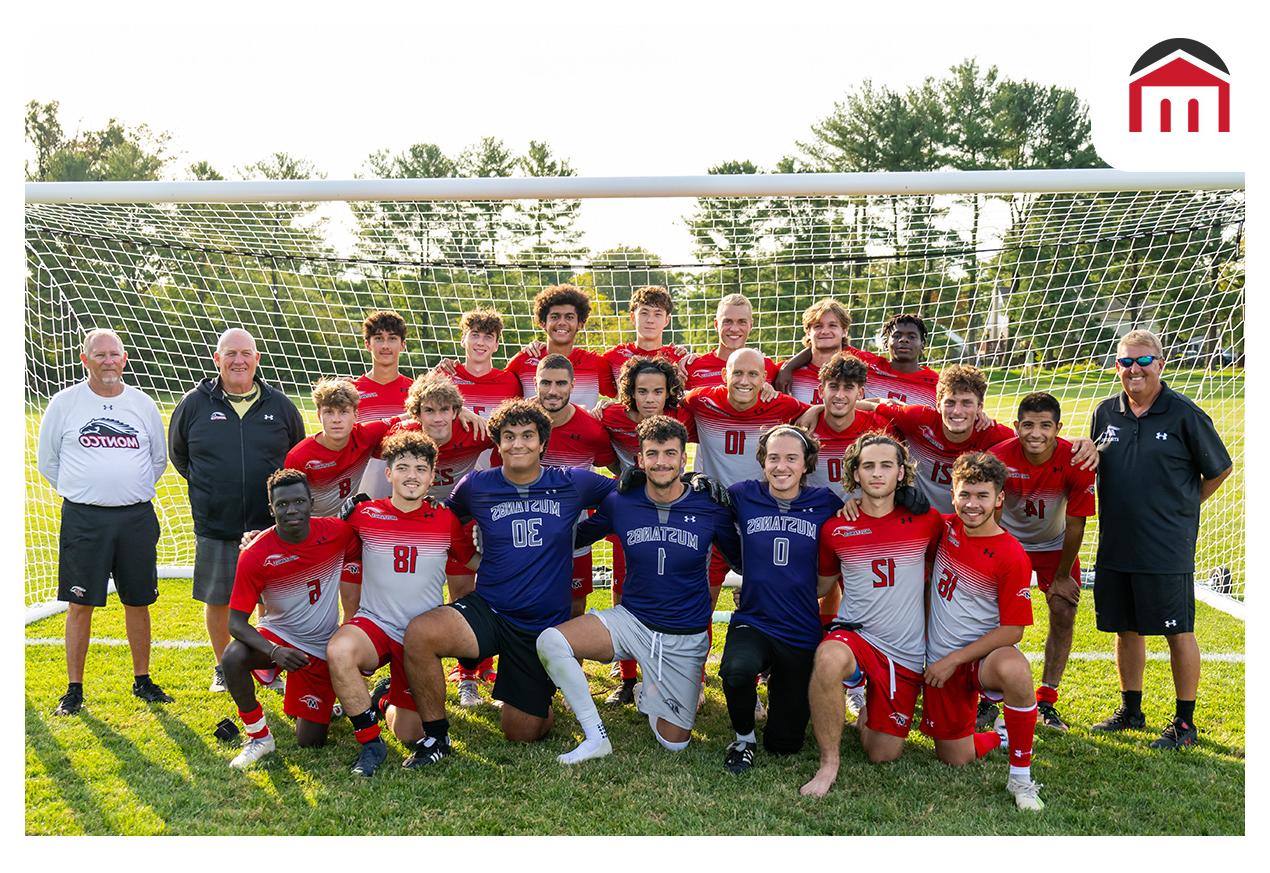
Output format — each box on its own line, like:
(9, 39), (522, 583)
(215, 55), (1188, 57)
(926, 516), (1033, 663)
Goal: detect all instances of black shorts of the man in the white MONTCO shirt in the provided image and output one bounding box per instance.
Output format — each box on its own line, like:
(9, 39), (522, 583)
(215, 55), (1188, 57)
(57, 501), (159, 606)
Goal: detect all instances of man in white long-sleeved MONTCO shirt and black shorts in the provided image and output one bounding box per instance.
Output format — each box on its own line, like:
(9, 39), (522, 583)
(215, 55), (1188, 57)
(39, 329), (171, 715)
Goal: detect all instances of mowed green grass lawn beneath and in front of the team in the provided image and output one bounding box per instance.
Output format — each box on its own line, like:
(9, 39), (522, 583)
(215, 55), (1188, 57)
(25, 579), (1245, 835)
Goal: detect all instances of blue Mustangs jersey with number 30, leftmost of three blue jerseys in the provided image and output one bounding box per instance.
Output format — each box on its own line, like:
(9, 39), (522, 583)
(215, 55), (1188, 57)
(446, 466), (617, 633)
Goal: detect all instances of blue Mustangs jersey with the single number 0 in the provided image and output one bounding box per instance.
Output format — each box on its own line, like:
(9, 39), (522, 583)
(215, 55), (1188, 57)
(728, 479), (842, 648)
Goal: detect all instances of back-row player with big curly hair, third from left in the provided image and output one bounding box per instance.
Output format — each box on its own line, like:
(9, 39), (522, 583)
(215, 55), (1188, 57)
(507, 285), (617, 409)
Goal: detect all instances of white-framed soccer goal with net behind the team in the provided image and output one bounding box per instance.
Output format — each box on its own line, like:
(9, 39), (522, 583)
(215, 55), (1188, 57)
(24, 170), (1246, 616)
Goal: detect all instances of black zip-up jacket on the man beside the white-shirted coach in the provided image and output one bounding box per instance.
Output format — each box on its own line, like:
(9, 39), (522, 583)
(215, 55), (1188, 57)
(168, 376), (305, 540)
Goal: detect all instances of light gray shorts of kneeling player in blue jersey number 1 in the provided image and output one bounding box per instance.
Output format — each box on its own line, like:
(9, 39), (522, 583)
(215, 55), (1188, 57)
(591, 605), (710, 731)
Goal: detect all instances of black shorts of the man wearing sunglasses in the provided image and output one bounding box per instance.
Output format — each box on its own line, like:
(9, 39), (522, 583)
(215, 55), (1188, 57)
(1093, 567), (1195, 637)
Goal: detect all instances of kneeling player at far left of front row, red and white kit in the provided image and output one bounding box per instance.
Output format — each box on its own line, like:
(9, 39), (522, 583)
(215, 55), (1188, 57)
(221, 469), (357, 768)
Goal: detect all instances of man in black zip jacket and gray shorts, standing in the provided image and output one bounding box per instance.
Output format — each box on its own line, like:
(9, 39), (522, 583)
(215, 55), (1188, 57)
(168, 328), (305, 691)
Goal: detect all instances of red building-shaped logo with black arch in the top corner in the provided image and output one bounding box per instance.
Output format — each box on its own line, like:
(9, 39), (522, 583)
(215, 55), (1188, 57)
(1129, 39), (1231, 133)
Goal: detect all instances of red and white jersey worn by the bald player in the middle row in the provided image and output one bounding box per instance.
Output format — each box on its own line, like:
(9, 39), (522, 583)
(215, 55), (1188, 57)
(683, 385), (808, 487)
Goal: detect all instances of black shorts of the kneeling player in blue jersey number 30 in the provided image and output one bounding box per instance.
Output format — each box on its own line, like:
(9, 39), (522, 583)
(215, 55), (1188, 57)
(448, 591), (555, 718)
